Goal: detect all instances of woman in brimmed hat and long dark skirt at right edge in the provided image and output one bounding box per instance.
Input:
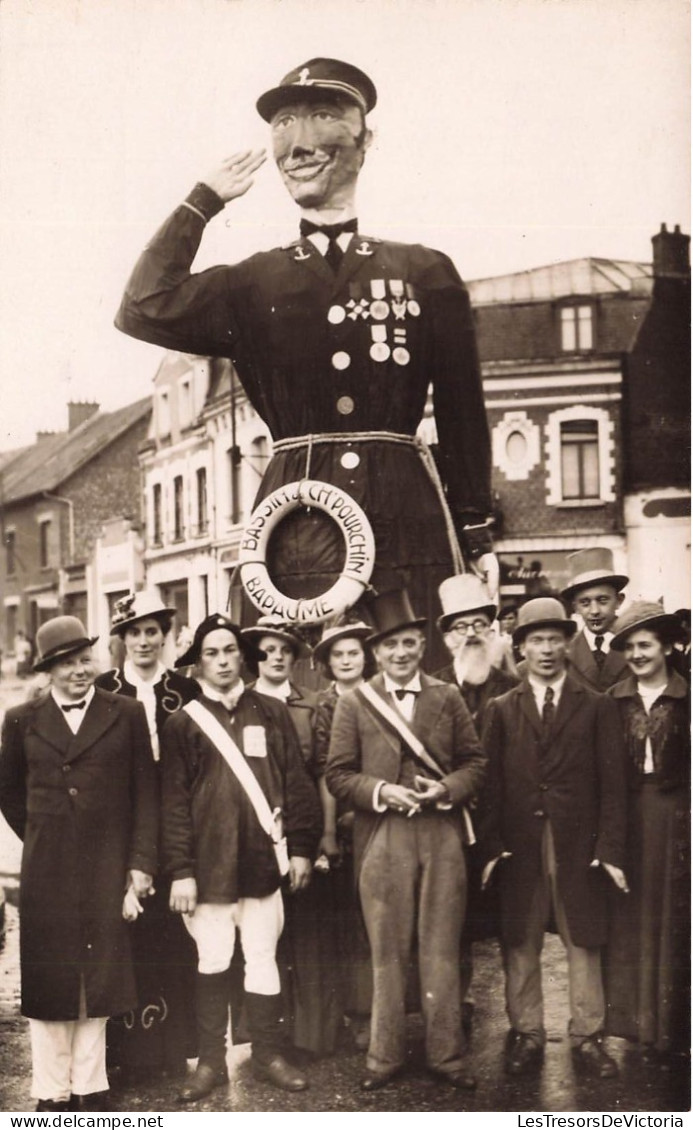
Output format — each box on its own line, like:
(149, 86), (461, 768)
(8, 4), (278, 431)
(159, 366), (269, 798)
(606, 601), (691, 1060)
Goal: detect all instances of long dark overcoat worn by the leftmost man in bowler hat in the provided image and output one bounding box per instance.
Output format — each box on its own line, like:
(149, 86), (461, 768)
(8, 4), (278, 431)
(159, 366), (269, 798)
(0, 689), (158, 1020)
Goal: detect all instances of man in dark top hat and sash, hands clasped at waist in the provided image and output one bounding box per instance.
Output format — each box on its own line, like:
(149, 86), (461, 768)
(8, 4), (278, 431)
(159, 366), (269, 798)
(326, 591), (485, 1090)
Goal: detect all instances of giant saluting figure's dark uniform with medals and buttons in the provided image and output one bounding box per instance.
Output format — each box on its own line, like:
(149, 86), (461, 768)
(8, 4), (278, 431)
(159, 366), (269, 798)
(115, 185), (491, 662)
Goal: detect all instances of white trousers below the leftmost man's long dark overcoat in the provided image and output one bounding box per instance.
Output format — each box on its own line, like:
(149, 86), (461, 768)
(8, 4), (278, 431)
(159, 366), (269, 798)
(29, 984), (109, 1103)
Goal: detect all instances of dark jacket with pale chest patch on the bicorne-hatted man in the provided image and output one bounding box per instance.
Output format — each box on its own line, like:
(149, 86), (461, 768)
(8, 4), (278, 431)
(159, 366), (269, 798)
(162, 689), (322, 903)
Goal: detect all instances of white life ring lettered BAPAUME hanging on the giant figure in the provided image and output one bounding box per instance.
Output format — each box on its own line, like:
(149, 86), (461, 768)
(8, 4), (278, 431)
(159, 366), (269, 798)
(239, 479), (375, 624)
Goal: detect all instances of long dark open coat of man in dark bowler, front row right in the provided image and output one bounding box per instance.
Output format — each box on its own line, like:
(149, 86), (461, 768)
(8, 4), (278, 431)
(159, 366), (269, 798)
(477, 676), (626, 947)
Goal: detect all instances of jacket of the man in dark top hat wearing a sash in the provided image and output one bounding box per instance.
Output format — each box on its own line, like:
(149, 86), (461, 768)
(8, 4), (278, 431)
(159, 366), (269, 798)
(326, 672), (485, 873)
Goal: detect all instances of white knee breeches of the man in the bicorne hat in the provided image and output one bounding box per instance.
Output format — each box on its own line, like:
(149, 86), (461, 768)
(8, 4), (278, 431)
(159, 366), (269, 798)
(183, 890), (284, 997)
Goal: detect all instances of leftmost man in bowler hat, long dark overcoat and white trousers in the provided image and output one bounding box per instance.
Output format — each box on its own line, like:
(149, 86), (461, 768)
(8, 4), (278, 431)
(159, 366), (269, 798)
(0, 616), (158, 1111)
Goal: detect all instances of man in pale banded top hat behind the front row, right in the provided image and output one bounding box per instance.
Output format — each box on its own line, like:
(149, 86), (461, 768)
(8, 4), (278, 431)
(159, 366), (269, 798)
(561, 547), (629, 693)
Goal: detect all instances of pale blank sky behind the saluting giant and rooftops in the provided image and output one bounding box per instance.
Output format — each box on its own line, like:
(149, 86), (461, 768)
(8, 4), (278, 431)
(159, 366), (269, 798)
(0, 0), (691, 451)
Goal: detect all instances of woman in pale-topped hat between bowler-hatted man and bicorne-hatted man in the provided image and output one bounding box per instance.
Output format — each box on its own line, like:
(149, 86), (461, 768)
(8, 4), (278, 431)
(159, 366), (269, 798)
(96, 592), (200, 1081)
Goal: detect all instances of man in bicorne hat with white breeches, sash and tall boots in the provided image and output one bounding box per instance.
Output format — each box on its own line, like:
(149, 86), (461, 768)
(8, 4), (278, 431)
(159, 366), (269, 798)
(162, 614), (321, 1103)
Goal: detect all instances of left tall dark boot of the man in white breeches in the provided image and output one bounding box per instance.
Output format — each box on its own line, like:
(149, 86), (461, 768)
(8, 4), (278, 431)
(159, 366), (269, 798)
(179, 971), (228, 1103)
